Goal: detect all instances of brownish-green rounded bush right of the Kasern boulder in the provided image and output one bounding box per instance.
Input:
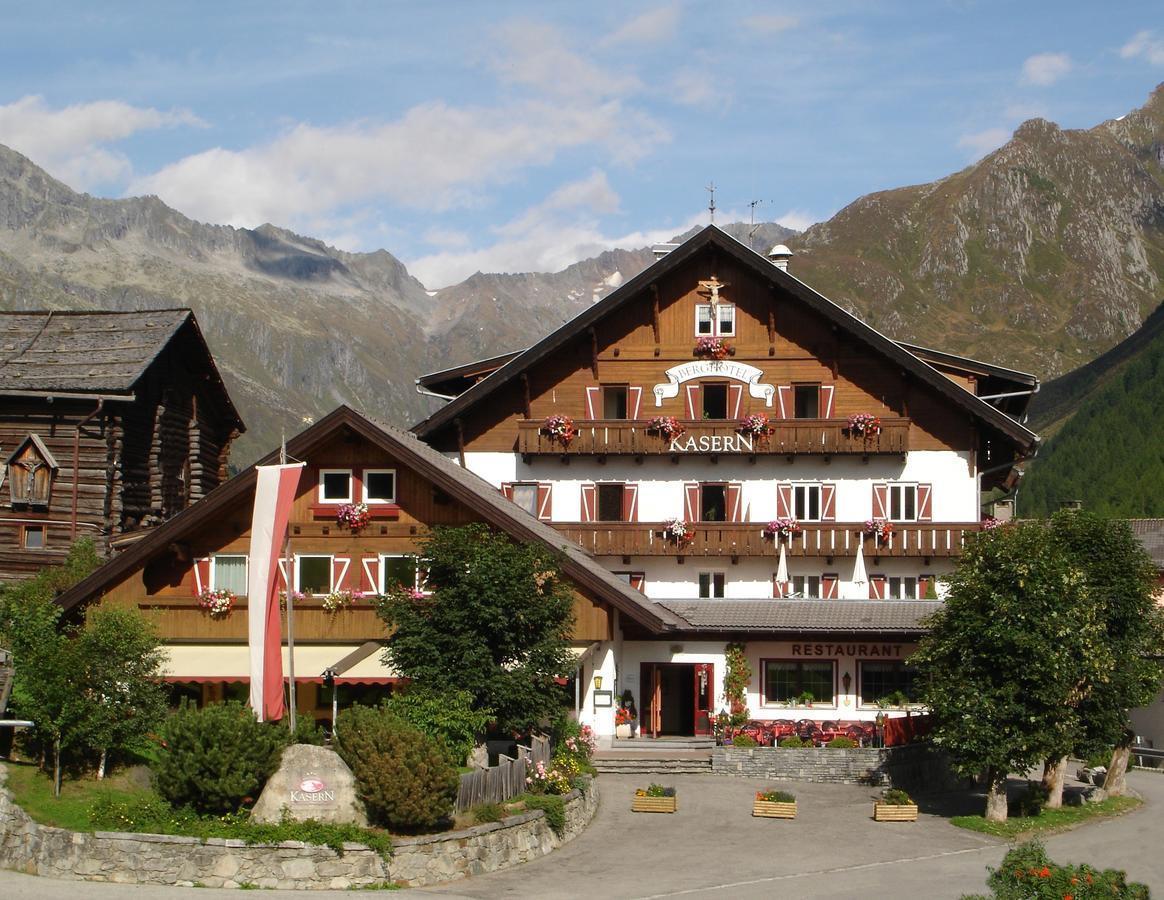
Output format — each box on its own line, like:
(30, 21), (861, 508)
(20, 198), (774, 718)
(335, 704), (459, 830)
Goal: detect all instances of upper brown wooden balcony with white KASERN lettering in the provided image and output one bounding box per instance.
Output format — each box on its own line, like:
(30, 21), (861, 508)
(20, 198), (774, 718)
(517, 418), (909, 458)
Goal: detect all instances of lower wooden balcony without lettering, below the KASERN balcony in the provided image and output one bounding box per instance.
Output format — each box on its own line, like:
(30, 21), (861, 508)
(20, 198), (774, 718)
(554, 522), (981, 560)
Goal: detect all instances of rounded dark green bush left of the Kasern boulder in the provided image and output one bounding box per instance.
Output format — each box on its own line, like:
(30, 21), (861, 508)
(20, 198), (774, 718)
(154, 701), (288, 814)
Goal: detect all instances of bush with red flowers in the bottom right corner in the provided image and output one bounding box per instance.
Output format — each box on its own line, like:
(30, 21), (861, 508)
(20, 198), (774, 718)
(968, 841), (1149, 900)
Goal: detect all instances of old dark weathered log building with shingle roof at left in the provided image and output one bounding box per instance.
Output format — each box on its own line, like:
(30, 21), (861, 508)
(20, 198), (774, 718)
(0, 310), (244, 581)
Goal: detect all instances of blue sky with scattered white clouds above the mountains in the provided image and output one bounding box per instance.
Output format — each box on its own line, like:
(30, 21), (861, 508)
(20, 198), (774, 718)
(0, 0), (1164, 288)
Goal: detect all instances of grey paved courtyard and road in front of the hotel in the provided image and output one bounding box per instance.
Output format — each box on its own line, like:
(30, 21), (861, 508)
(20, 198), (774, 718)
(0, 772), (1164, 900)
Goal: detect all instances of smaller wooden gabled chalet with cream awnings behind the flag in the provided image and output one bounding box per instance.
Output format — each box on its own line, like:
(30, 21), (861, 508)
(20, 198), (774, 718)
(58, 406), (680, 717)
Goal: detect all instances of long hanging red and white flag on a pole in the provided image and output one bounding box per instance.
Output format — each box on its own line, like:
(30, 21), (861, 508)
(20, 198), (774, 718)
(247, 462), (303, 722)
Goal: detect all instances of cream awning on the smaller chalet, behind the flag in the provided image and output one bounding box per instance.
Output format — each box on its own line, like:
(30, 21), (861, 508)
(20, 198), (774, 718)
(162, 644), (399, 685)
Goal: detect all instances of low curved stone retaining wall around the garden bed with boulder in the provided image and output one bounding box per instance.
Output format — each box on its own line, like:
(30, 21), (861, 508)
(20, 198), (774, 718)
(0, 765), (598, 891)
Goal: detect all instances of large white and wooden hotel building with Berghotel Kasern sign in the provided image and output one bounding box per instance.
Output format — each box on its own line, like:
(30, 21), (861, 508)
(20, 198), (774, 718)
(413, 226), (1038, 736)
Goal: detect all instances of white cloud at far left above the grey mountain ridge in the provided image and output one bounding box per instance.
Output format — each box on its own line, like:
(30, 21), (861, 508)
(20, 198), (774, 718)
(0, 95), (204, 190)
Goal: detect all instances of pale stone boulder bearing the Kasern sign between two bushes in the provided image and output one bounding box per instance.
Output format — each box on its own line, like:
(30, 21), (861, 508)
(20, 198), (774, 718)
(250, 744), (368, 825)
